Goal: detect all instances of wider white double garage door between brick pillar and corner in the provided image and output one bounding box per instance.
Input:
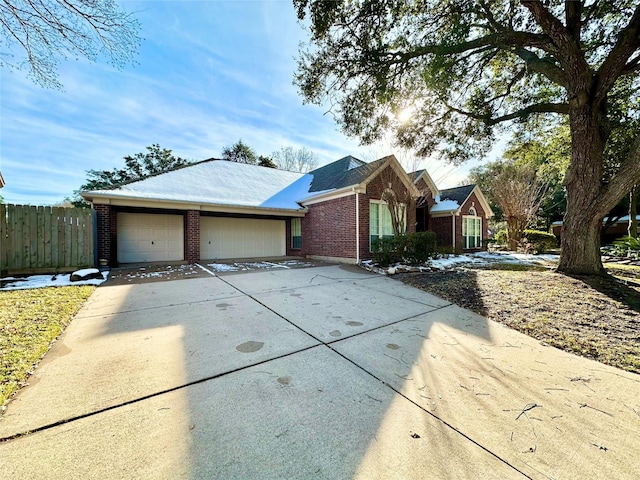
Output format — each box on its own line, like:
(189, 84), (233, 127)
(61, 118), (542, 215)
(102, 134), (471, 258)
(200, 217), (286, 259)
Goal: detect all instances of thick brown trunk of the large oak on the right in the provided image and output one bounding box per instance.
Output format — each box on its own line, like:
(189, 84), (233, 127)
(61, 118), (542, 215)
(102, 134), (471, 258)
(558, 92), (610, 275)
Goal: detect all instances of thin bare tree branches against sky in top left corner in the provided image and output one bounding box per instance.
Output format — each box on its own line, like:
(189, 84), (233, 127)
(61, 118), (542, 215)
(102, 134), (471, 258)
(0, 0), (140, 88)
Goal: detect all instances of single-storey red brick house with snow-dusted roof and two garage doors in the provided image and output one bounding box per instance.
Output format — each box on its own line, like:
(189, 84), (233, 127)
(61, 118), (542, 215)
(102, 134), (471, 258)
(82, 155), (490, 266)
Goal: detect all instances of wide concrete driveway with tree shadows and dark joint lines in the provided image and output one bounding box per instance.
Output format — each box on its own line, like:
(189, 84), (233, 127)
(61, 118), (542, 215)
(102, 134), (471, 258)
(0, 266), (640, 479)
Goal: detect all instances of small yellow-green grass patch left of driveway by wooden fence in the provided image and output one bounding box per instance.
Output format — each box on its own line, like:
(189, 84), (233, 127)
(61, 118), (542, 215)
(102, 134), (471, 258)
(0, 285), (96, 406)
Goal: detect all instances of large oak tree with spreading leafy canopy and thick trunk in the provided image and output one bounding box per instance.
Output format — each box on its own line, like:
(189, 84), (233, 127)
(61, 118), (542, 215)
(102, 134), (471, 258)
(294, 0), (640, 274)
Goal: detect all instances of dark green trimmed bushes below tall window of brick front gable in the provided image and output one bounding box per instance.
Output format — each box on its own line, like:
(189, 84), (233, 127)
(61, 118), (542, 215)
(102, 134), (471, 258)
(371, 231), (437, 267)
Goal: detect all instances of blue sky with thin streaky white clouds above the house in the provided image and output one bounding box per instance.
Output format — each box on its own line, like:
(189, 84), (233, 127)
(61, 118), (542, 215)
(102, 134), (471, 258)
(0, 0), (482, 205)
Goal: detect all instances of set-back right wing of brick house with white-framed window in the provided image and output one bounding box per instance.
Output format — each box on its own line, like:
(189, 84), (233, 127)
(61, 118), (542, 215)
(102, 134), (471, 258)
(410, 170), (493, 252)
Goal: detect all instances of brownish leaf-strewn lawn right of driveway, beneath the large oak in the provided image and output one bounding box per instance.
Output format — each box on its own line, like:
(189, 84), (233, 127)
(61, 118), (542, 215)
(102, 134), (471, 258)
(398, 263), (640, 373)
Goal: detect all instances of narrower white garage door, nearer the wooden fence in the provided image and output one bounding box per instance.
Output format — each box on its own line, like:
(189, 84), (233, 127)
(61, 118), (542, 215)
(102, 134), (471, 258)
(118, 213), (184, 263)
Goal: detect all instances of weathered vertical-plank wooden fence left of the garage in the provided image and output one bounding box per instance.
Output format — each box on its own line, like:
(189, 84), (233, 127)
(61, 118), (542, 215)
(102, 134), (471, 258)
(0, 204), (95, 275)
